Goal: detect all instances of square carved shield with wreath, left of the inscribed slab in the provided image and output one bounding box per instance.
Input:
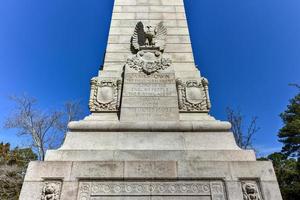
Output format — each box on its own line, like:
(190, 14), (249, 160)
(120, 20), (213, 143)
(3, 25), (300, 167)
(89, 77), (122, 112)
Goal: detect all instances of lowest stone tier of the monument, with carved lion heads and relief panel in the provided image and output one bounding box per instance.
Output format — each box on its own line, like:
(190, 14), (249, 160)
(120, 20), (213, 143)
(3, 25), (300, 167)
(20, 160), (281, 200)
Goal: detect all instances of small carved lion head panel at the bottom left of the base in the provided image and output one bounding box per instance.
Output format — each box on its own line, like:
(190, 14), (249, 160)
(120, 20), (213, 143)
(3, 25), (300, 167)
(41, 182), (61, 200)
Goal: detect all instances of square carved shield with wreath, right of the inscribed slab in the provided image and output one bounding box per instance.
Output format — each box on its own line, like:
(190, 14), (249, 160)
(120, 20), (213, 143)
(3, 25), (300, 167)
(176, 78), (211, 112)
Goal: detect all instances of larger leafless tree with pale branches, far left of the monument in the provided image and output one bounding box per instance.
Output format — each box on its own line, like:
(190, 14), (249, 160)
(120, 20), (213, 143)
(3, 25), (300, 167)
(4, 95), (62, 160)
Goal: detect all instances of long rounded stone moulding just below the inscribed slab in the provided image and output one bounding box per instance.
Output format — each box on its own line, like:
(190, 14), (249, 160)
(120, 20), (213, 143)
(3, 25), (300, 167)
(68, 120), (231, 132)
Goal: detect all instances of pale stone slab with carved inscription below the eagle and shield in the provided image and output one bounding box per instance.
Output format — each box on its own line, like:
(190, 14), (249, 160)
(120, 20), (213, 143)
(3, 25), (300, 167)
(121, 67), (179, 122)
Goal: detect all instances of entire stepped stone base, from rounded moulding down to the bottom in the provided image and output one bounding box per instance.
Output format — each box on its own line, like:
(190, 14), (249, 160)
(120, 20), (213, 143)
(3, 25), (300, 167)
(20, 119), (282, 200)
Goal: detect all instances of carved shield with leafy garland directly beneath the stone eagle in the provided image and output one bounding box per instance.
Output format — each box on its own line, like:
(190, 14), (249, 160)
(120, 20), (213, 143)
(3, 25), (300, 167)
(126, 50), (172, 75)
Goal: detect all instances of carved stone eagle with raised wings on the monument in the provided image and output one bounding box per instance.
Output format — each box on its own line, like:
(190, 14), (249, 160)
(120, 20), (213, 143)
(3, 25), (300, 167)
(131, 22), (167, 51)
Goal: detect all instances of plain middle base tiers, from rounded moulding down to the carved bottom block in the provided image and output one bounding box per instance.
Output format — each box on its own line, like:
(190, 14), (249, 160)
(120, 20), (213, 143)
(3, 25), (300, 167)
(45, 120), (256, 161)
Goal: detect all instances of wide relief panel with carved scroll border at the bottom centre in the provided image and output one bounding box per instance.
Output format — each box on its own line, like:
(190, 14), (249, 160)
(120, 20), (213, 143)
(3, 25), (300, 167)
(78, 181), (226, 200)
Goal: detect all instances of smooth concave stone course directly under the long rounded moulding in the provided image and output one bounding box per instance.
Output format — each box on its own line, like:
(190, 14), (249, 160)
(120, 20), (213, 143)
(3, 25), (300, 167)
(56, 130), (243, 152)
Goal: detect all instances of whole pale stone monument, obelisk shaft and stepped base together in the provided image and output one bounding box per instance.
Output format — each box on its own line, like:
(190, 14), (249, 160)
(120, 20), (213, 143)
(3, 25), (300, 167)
(20, 0), (282, 200)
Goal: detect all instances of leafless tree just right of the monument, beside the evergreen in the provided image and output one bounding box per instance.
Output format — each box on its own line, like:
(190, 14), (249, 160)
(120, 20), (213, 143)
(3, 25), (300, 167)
(226, 107), (260, 149)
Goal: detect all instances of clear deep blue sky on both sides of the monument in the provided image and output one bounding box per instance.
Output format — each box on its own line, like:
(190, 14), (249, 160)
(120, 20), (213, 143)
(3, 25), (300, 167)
(0, 0), (300, 154)
